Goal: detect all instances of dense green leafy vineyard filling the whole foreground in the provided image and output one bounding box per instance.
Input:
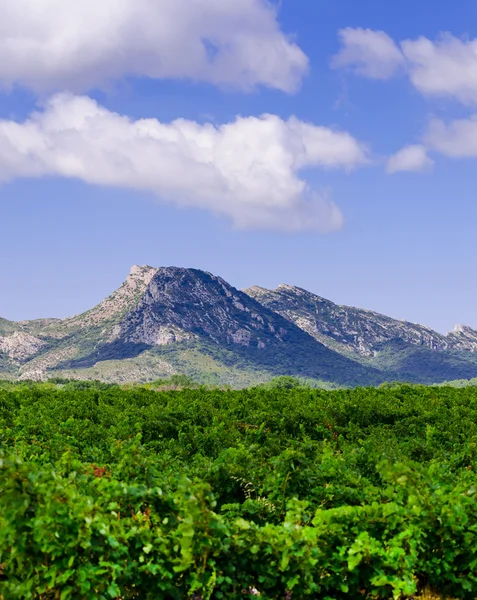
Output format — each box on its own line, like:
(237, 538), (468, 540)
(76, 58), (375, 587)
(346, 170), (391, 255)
(0, 380), (477, 600)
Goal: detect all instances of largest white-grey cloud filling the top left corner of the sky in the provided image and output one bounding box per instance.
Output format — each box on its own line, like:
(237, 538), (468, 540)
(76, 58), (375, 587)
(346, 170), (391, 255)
(0, 0), (308, 92)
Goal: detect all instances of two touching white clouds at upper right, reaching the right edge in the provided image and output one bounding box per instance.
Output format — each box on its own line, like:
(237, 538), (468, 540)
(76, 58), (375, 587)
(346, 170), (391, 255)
(332, 28), (477, 105)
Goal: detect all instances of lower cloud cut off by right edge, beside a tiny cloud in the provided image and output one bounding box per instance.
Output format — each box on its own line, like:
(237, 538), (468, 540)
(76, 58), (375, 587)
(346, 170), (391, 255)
(425, 115), (477, 158)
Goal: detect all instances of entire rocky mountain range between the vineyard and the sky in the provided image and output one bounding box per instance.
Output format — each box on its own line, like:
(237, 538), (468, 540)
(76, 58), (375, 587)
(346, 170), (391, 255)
(0, 266), (477, 387)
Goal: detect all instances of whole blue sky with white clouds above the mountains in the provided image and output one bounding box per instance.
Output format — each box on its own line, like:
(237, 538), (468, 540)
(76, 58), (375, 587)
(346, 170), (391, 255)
(0, 0), (477, 333)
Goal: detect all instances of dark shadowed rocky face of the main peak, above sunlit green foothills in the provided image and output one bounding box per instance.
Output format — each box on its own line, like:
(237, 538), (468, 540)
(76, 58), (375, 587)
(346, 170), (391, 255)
(54, 267), (378, 384)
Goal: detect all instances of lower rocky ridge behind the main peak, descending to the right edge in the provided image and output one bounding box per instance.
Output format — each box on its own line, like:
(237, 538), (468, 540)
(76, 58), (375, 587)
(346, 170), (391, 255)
(245, 284), (477, 383)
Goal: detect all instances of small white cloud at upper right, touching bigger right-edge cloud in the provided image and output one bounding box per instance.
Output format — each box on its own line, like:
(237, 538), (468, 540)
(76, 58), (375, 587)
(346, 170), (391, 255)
(331, 27), (404, 79)
